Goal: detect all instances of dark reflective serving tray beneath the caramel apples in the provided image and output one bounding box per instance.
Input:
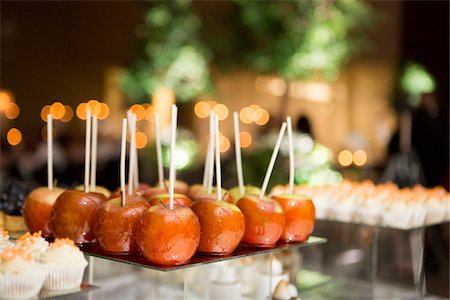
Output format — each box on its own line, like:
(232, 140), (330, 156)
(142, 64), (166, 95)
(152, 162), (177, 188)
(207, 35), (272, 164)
(81, 236), (327, 272)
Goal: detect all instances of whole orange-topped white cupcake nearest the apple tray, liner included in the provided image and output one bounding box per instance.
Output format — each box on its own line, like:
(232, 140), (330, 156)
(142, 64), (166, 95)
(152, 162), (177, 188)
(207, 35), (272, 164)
(41, 238), (87, 291)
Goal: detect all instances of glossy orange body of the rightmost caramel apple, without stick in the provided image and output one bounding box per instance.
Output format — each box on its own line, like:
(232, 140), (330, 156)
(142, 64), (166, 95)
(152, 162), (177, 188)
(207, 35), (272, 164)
(272, 194), (316, 242)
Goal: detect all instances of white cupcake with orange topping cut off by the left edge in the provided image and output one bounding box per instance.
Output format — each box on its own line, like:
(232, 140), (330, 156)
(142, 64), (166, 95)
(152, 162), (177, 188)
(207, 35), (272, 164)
(0, 247), (47, 299)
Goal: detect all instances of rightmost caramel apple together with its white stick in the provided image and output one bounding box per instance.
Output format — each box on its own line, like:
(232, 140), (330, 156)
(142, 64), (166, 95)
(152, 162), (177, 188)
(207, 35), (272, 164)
(272, 117), (316, 242)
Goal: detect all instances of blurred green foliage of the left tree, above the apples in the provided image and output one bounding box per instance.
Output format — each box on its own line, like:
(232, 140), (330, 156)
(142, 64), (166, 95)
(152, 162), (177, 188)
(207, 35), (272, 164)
(122, 0), (211, 102)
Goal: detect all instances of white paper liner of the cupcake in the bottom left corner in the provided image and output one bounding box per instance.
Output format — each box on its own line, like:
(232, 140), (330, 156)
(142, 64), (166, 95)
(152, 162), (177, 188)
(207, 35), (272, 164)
(0, 267), (47, 299)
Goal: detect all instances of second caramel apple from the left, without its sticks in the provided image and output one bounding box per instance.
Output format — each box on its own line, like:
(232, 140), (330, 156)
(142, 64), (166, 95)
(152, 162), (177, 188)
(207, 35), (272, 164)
(51, 190), (106, 245)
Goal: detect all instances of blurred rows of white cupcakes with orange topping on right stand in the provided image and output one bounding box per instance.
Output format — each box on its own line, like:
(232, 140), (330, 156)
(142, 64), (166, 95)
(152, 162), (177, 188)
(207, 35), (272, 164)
(272, 181), (450, 229)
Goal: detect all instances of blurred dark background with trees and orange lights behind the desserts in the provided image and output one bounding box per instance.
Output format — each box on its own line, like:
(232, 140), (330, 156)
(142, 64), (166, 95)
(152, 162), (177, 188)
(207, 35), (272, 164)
(0, 0), (449, 195)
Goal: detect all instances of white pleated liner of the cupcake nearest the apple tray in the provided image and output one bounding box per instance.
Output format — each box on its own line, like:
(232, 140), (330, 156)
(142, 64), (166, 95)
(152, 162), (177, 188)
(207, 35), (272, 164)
(44, 262), (87, 291)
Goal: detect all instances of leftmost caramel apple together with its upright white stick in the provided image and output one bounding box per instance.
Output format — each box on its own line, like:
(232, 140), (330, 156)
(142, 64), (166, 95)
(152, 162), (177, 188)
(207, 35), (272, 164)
(23, 114), (64, 237)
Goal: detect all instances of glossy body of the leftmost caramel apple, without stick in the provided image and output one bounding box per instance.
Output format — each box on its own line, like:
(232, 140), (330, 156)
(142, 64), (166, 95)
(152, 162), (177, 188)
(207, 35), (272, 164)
(23, 187), (64, 238)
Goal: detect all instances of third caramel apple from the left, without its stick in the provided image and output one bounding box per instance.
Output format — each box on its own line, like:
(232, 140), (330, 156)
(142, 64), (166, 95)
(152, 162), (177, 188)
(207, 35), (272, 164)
(94, 195), (150, 254)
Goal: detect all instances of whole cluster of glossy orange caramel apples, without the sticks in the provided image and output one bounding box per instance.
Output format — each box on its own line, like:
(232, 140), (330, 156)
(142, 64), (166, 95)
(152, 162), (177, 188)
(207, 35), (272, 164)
(24, 181), (315, 265)
